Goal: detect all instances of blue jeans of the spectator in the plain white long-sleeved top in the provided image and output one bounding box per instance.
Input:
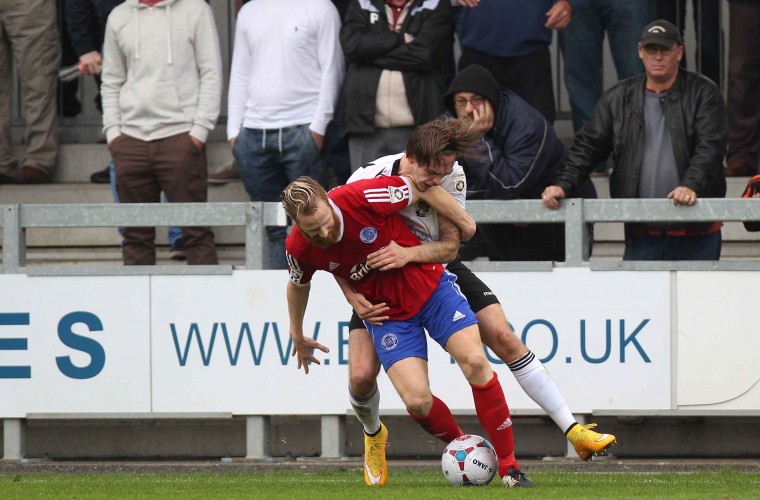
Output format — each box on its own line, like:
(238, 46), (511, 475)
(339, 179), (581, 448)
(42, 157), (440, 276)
(232, 124), (326, 269)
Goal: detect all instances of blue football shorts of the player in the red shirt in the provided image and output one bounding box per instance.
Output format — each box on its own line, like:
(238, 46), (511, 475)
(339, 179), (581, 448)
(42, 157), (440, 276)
(365, 271), (478, 371)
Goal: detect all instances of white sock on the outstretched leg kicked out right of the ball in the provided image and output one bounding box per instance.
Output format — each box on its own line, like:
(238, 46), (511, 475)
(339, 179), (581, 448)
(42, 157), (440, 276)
(507, 351), (575, 432)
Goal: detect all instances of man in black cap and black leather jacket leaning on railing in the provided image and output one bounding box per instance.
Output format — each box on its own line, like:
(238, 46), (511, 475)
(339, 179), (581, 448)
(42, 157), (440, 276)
(542, 19), (728, 260)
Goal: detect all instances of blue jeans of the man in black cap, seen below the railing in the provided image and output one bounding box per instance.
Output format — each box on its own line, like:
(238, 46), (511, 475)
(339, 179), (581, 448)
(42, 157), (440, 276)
(623, 231), (722, 260)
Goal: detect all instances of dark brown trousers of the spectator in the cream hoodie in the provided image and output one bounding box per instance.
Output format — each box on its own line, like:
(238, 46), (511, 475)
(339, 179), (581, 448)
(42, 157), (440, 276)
(108, 133), (219, 266)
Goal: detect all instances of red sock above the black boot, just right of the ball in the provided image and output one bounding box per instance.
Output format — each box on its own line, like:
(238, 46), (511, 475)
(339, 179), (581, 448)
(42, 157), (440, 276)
(471, 372), (519, 477)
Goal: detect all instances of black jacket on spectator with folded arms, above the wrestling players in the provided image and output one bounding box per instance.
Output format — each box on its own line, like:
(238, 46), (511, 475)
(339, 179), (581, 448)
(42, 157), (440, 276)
(340, 0), (454, 135)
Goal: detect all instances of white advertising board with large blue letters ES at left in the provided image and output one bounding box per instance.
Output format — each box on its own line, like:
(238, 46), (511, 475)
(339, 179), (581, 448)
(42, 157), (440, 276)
(0, 275), (150, 417)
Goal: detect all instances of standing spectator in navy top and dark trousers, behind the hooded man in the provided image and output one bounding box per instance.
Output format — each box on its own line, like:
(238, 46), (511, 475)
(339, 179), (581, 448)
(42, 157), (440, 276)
(459, 0), (580, 123)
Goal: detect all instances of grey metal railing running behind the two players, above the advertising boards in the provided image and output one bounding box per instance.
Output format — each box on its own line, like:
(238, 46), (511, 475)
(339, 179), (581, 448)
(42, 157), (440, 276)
(0, 199), (760, 275)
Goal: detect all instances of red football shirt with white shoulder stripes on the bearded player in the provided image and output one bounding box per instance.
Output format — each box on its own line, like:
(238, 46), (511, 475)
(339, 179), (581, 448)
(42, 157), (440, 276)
(285, 176), (443, 321)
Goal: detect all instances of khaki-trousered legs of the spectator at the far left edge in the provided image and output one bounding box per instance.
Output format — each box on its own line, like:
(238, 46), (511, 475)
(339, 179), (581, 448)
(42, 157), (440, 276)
(0, 0), (61, 184)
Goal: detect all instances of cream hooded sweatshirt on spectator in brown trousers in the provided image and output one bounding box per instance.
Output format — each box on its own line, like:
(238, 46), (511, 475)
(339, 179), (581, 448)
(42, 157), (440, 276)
(101, 0), (222, 142)
